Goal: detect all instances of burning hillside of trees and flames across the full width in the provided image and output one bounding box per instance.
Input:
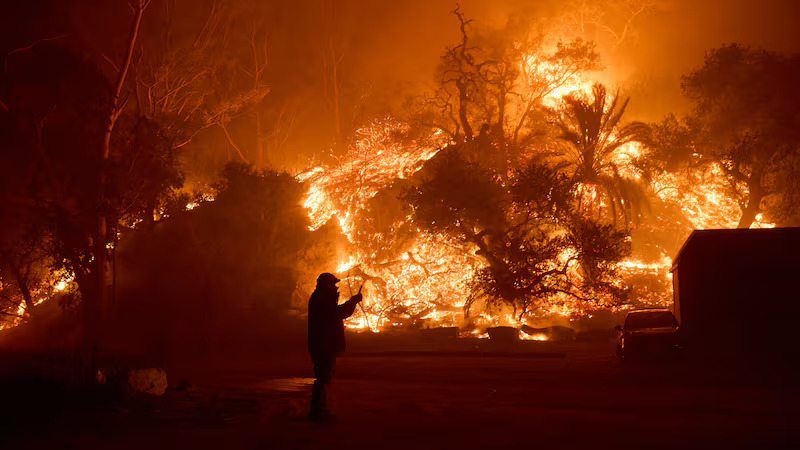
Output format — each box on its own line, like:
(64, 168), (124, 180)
(0, 1), (800, 342)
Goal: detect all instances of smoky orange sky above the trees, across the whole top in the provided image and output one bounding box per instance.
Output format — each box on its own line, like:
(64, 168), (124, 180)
(6, 0), (800, 172)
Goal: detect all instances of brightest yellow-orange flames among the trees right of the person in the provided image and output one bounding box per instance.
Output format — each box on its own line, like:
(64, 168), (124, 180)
(298, 57), (770, 334)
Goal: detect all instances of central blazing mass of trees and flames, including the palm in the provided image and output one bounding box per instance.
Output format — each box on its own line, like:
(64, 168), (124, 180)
(290, 11), (784, 331)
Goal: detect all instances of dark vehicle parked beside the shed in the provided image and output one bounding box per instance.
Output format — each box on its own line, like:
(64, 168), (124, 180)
(617, 309), (681, 360)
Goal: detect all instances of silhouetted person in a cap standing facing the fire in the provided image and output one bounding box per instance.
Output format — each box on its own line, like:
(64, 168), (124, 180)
(308, 272), (363, 419)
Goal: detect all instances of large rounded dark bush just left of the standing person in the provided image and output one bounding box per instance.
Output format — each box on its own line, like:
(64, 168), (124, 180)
(113, 163), (324, 357)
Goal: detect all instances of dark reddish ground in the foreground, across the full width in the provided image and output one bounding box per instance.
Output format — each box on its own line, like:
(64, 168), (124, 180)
(2, 340), (800, 450)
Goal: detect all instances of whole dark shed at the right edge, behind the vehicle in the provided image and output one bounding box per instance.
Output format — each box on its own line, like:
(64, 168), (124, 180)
(670, 228), (800, 354)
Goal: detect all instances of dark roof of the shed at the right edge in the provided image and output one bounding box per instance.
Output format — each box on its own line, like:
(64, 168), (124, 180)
(670, 227), (800, 272)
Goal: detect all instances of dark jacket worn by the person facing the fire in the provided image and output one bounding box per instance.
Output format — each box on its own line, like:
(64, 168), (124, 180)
(308, 287), (358, 356)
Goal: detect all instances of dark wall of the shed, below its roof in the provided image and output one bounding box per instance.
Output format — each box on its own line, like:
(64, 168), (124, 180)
(673, 253), (800, 353)
